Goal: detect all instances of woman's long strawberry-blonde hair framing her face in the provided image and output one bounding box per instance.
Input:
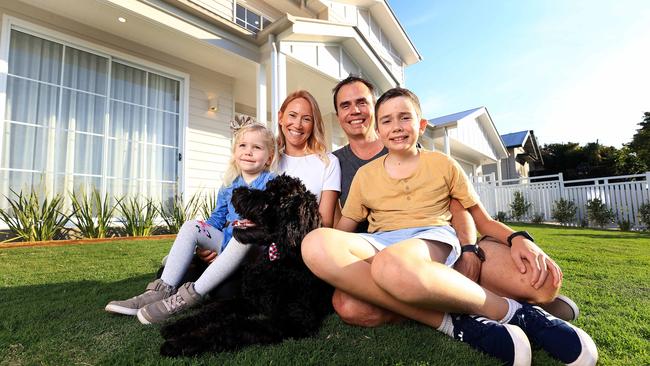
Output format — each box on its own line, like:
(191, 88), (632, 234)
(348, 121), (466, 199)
(278, 90), (330, 165)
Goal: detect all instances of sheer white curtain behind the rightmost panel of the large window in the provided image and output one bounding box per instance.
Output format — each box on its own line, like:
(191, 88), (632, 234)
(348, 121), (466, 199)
(107, 61), (180, 206)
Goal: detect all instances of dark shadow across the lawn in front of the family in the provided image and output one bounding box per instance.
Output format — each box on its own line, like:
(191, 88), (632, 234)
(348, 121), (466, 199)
(0, 274), (554, 365)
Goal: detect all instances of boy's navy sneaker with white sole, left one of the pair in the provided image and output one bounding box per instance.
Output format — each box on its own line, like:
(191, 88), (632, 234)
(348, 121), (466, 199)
(450, 314), (532, 366)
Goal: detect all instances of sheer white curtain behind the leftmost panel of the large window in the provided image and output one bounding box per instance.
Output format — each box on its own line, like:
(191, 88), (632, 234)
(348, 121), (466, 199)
(0, 31), (63, 203)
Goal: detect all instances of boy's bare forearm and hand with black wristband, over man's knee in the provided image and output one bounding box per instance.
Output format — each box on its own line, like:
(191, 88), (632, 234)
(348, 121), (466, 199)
(468, 203), (562, 288)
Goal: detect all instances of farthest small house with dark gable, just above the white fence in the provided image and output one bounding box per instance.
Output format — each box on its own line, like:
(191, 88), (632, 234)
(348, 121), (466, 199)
(483, 130), (544, 180)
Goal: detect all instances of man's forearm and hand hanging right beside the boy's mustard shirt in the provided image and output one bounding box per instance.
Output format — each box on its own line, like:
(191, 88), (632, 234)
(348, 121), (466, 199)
(449, 198), (481, 282)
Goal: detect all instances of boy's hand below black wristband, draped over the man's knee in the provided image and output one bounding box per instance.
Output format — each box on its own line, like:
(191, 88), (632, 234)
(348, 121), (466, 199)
(510, 237), (563, 289)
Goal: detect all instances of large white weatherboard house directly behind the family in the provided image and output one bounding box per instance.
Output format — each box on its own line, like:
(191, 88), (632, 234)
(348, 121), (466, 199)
(0, 0), (421, 207)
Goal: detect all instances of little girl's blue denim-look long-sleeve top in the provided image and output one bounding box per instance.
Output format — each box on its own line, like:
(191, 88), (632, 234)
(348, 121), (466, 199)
(206, 171), (275, 251)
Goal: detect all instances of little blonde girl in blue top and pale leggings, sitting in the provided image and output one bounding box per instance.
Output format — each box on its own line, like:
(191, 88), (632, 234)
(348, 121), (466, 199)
(106, 120), (277, 324)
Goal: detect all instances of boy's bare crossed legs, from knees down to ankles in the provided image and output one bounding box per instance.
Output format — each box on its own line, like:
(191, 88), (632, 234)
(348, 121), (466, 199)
(302, 229), (507, 328)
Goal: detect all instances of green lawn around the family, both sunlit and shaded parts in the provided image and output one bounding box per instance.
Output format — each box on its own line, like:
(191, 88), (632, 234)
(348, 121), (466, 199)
(0, 225), (650, 365)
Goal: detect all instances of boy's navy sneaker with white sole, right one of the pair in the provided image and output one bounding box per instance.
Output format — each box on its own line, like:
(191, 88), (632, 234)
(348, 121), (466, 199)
(509, 303), (598, 366)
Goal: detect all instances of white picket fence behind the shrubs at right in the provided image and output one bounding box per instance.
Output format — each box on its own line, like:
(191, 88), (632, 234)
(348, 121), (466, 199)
(473, 172), (650, 229)
